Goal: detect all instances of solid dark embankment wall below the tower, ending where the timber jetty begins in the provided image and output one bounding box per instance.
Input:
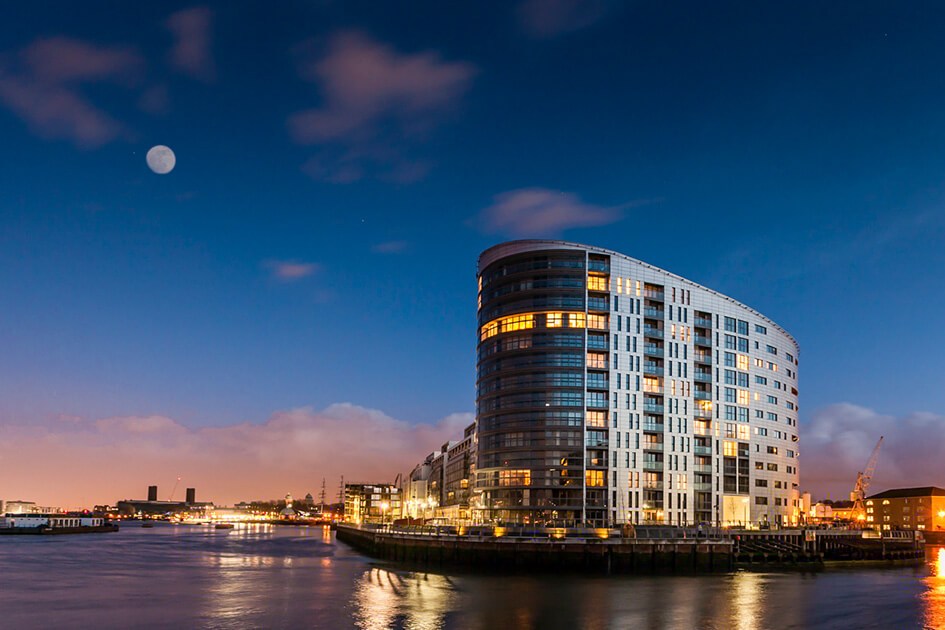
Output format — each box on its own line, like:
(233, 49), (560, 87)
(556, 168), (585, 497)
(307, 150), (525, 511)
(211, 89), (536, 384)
(337, 526), (733, 574)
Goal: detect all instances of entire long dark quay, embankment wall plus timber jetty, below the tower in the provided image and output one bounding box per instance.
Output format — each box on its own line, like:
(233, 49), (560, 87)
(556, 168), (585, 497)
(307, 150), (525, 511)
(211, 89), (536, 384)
(337, 525), (924, 574)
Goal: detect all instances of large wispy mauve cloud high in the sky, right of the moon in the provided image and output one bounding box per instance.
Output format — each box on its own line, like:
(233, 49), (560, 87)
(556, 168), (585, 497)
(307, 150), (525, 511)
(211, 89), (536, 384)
(287, 31), (476, 183)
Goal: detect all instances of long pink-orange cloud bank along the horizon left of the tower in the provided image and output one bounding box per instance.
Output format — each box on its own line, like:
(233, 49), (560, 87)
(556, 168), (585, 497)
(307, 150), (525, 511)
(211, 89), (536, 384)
(0, 403), (473, 507)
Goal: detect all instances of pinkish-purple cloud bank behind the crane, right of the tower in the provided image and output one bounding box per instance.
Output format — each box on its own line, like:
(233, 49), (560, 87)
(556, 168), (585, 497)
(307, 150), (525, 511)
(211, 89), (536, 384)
(798, 403), (945, 499)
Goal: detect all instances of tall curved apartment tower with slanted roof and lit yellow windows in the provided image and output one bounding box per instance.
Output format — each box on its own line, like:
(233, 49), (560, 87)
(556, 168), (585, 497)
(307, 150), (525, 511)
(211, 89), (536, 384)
(471, 240), (799, 526)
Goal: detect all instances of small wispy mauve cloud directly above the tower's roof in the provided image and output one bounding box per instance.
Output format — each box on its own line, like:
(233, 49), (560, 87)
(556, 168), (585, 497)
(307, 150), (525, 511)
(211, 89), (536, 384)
(474, 188), (646, 236)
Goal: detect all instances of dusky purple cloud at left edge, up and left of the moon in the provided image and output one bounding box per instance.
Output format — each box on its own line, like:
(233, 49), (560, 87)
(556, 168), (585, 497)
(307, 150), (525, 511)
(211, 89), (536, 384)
(0, 37), (144, 148)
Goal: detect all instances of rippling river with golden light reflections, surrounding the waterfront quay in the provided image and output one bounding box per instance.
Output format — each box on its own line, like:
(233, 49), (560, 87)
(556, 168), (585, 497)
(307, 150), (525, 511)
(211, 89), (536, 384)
(0, 524), (945, 630)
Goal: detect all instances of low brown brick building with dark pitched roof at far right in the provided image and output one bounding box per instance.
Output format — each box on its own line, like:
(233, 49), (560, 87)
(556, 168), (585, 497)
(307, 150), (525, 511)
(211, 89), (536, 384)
(866, 486), (945, 532)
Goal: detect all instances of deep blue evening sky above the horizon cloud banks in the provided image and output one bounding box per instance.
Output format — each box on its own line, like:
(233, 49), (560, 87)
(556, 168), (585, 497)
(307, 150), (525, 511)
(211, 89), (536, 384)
(0, 0), (945, 436)
